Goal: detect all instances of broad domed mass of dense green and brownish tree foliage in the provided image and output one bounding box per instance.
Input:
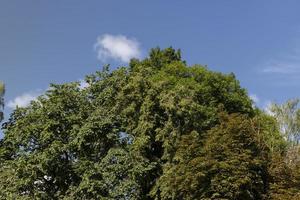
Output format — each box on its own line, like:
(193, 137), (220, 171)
(0, 48), (300, 200)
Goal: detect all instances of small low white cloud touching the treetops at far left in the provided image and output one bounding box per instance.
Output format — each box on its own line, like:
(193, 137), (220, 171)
(7, 92), (40, 109)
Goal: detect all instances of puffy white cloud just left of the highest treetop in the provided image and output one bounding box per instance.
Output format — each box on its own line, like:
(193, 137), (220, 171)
(94, 34), (141, 62)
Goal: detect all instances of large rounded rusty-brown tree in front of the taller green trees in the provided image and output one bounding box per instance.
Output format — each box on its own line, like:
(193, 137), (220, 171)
(155, 114), (268, 200)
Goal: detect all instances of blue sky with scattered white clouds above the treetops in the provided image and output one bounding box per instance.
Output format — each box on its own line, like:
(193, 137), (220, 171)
(0, 0), (300, 135)
